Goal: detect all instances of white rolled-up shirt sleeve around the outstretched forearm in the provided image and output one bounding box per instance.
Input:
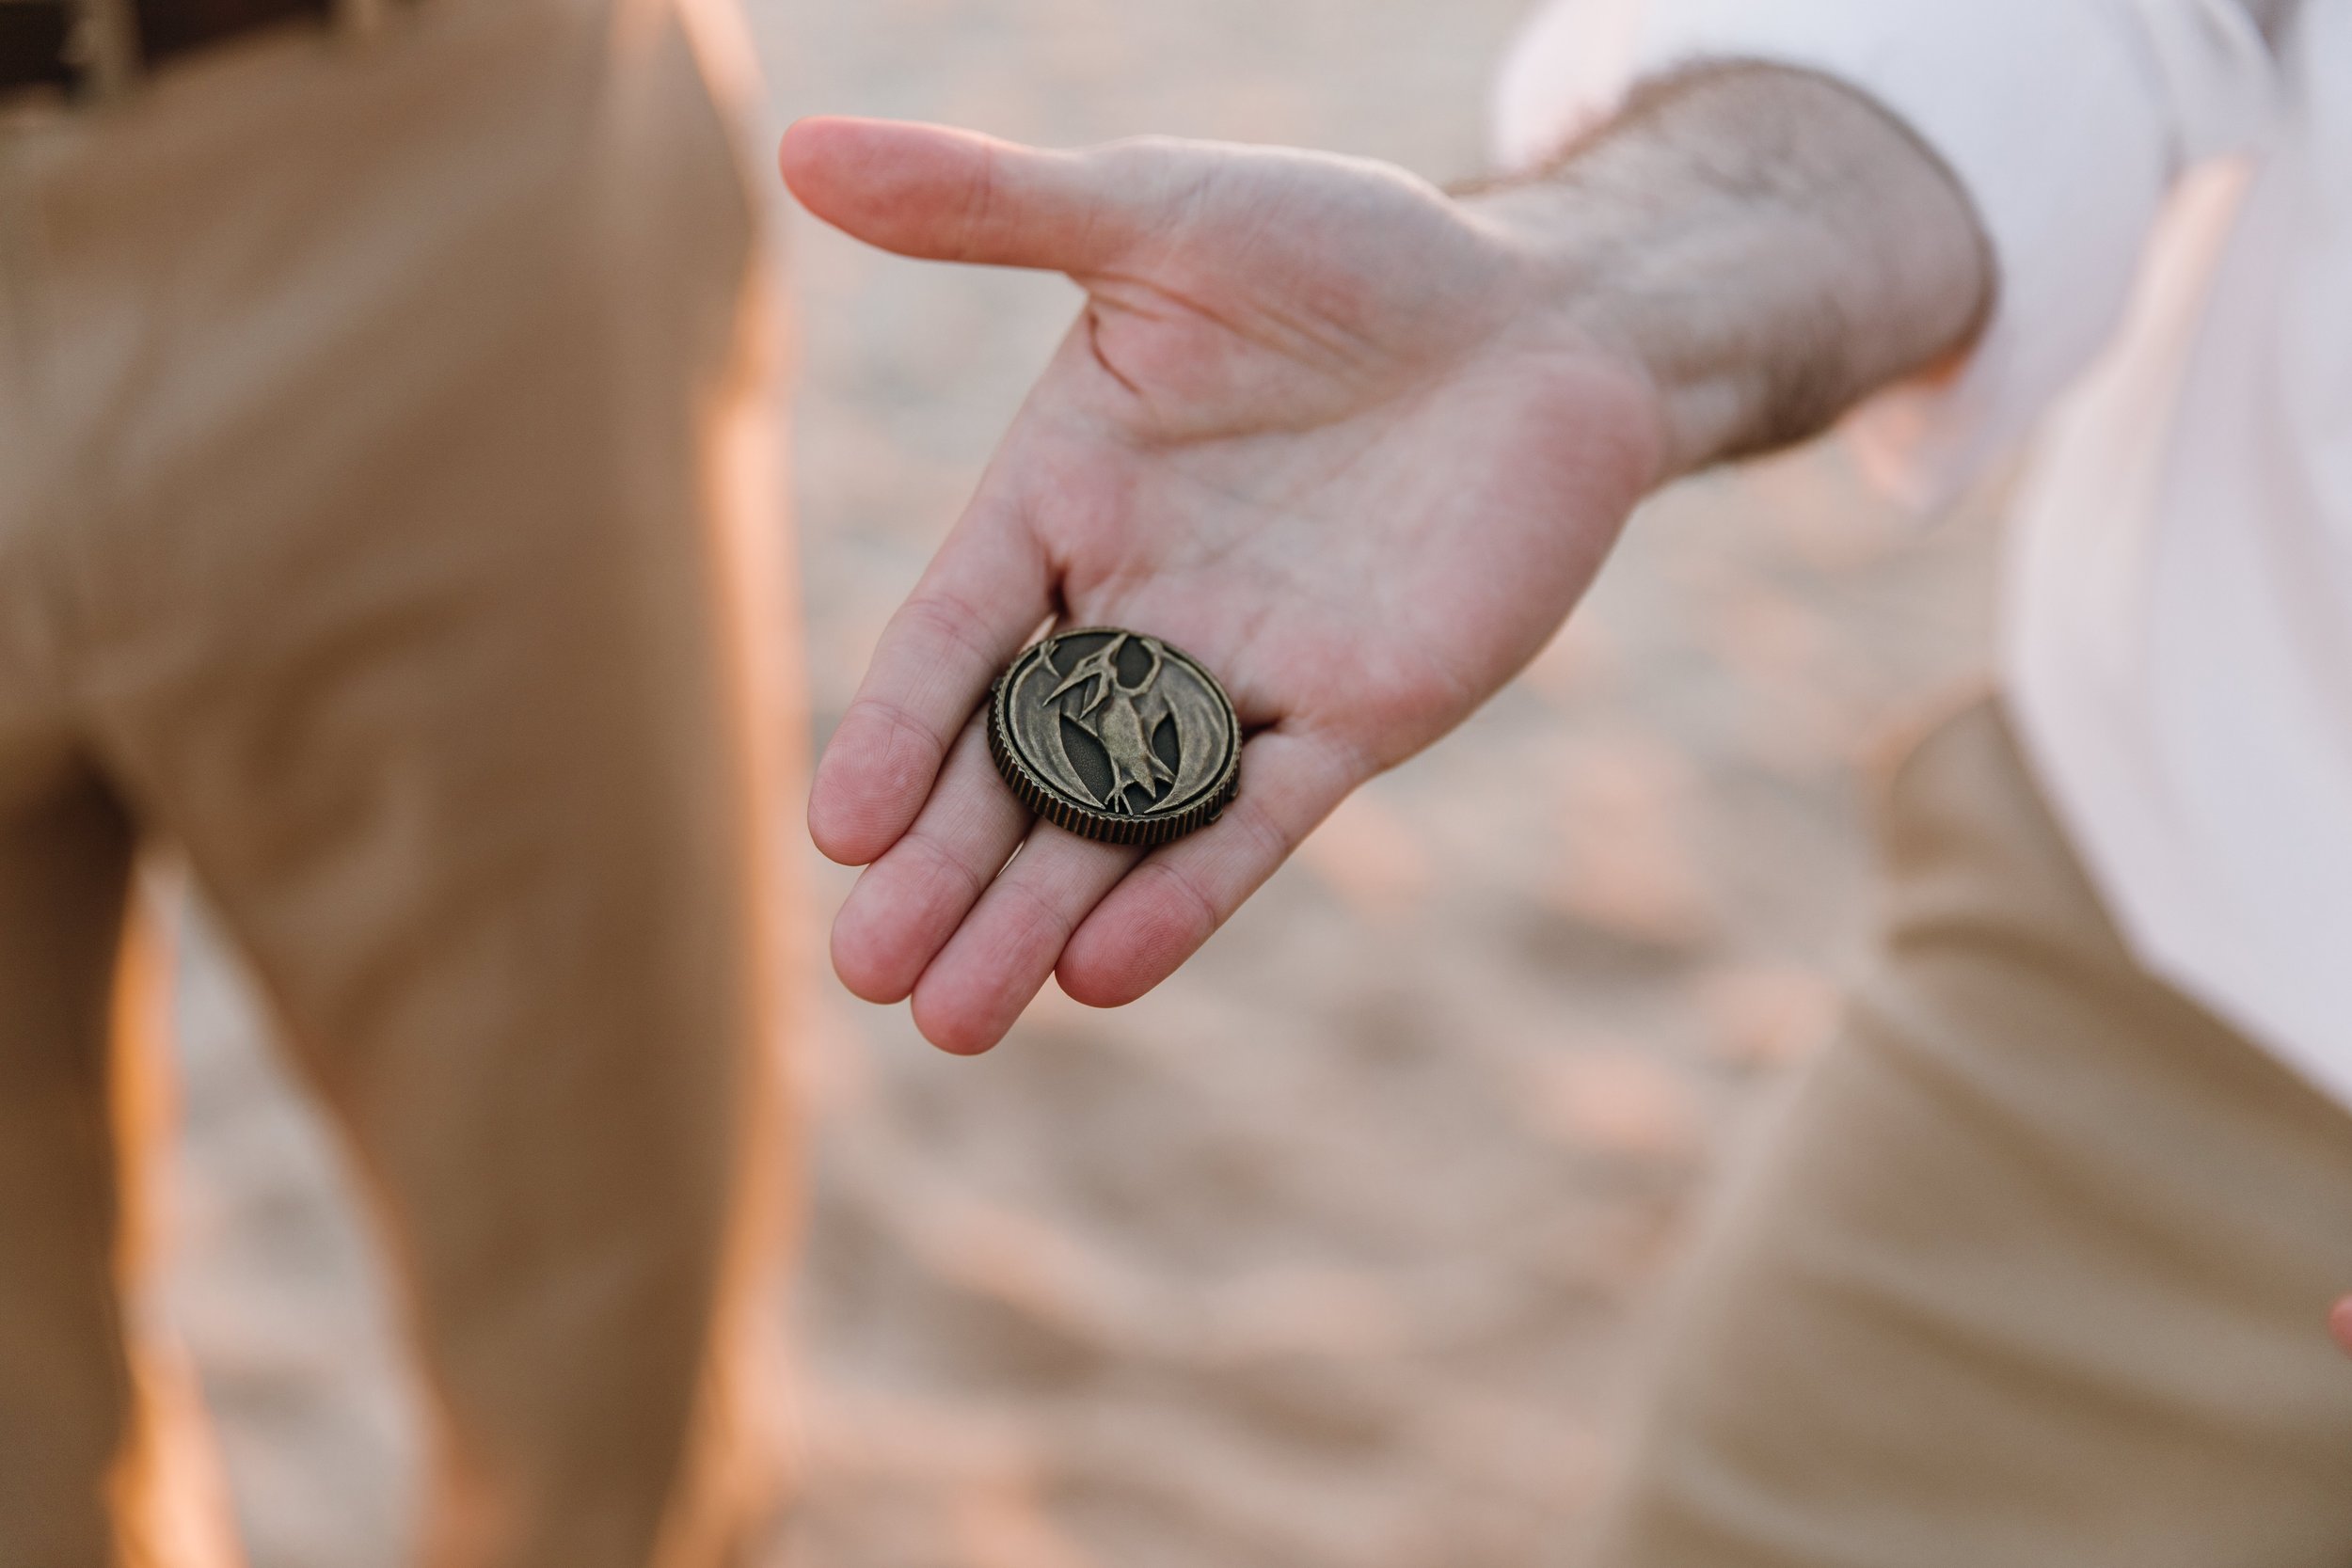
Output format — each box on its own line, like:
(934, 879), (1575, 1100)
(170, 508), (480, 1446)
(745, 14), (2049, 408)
(1494, 0), (2277, 505)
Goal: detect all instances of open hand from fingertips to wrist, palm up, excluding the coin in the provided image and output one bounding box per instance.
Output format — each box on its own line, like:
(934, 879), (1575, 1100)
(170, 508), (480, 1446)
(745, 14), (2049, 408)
(784, 119), (1661, 1051)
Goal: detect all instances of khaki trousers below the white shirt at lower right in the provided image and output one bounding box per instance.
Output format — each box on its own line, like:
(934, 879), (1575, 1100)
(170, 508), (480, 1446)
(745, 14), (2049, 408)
(1599, 705), (2352, 1568)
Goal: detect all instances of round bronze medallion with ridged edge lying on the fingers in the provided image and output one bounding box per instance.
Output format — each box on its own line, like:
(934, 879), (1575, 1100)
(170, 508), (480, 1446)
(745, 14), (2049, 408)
(988, 626), (1242, 844)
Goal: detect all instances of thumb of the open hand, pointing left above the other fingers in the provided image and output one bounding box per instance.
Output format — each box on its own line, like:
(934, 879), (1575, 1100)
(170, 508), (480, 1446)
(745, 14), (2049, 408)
(776, 118), (1138, 273)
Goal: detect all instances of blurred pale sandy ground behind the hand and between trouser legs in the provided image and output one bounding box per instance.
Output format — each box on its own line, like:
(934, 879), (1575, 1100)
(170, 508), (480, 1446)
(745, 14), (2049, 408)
(172, 0), (1990, 1568)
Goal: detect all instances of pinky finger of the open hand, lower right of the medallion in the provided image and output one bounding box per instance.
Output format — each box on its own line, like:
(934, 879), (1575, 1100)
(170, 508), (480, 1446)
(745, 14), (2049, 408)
(1054, 729), (1369, 1006)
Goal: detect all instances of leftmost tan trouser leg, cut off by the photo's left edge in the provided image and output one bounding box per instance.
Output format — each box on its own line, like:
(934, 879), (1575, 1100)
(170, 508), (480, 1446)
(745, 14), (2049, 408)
(0, 152), (235, 1568)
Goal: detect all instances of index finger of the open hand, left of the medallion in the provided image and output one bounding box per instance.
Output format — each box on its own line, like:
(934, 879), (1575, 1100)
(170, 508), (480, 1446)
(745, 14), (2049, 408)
(809, 503), (1052, 865)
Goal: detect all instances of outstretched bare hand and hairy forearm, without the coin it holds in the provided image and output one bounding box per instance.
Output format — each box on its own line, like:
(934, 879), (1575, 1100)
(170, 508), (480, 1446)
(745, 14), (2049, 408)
(781, 76), (1993, 1051)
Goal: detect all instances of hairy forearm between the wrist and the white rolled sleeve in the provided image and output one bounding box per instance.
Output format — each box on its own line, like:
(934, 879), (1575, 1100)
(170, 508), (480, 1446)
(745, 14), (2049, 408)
(1466, 66), (1994, 477)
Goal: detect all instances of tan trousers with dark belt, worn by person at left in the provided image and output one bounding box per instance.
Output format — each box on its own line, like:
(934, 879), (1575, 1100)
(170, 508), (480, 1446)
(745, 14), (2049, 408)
(0, 0), (784, 1568)
